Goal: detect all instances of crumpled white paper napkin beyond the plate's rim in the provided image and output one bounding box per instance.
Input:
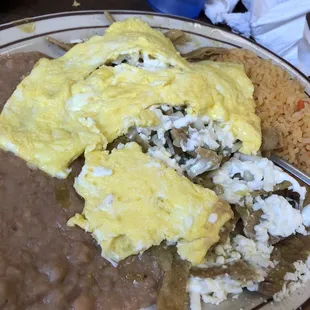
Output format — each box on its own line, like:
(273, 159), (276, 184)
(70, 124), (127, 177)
(205, 0), (310, 76)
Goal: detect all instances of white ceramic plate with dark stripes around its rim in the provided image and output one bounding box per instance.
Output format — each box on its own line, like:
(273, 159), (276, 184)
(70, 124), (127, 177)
(0, 11), (310, 310)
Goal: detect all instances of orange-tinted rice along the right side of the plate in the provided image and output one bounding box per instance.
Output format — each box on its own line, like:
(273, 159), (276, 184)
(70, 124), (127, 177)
(212, 49), (310, 174)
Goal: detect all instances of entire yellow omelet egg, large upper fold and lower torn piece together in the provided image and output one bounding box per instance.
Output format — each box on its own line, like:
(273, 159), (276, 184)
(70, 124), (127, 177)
(0, 19), (261, 264)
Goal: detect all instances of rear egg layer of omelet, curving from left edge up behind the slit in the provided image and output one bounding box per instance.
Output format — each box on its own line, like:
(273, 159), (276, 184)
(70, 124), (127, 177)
(0, 19), (187, 178)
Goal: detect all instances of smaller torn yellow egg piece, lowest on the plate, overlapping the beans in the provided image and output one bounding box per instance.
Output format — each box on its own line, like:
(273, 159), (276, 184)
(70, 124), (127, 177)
(68, 143), (233, 264)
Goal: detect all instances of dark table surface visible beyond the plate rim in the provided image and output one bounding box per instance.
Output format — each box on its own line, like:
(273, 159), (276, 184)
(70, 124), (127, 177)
(0, 0), (310, 310)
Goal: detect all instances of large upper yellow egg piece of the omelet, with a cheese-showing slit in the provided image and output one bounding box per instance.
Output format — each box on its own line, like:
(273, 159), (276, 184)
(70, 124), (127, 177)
(0, 19), (261, 178)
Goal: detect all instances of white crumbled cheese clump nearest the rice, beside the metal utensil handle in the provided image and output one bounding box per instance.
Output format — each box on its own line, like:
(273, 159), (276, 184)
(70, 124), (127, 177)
(212, 153), (306, 205)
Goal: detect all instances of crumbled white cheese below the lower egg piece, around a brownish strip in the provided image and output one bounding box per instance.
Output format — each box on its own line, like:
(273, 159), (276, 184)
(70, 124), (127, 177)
(191, 235), (274, 309)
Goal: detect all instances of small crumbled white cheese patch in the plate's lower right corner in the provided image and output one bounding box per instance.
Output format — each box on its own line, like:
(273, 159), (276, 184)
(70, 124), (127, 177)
(273, 255), (310, 301)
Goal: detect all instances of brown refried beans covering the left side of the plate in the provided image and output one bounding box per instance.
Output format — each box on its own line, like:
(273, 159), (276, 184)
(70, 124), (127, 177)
(0, 52), (163, 310)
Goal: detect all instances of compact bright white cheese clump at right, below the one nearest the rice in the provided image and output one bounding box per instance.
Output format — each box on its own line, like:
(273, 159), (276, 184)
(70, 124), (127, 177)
(253, 195), (307, 243)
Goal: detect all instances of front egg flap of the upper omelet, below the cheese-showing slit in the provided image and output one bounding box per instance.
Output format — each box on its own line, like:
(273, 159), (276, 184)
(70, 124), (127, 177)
(66, 61), (261, 154)
